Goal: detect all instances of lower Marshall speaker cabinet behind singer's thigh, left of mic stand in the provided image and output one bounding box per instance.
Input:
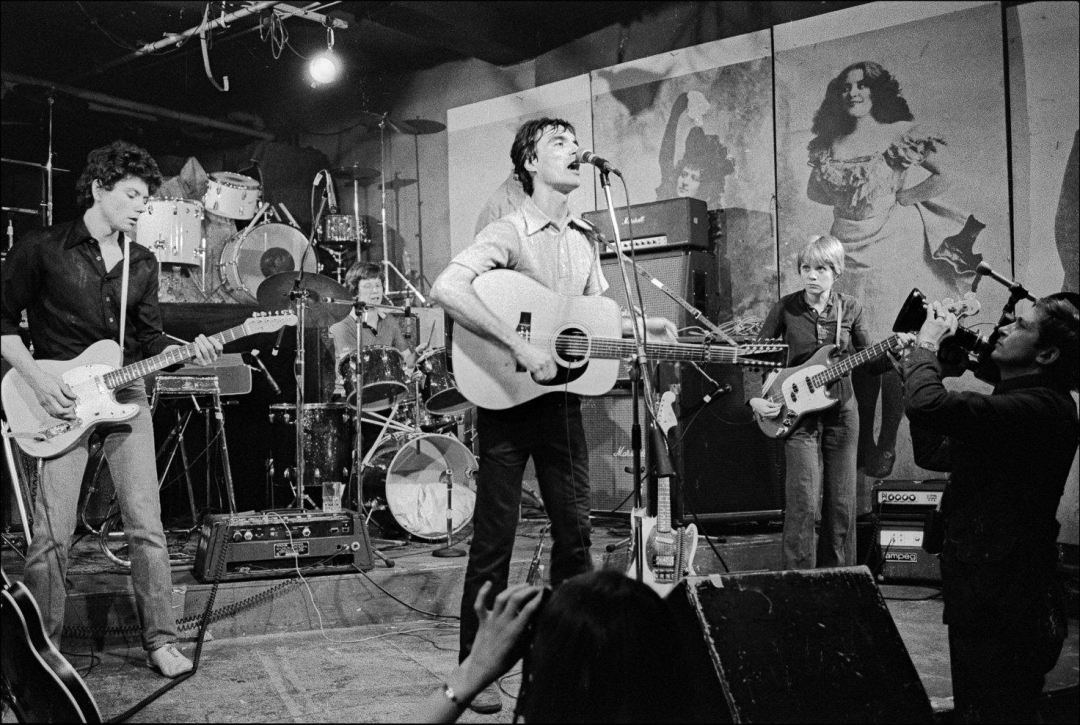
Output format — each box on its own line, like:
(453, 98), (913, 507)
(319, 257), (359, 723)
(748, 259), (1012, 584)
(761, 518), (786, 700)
(581, 390), (644, 513)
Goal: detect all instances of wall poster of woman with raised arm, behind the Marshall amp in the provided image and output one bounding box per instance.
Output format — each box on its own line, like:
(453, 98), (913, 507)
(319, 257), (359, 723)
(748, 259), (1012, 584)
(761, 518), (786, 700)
(592, 31), (777, 320)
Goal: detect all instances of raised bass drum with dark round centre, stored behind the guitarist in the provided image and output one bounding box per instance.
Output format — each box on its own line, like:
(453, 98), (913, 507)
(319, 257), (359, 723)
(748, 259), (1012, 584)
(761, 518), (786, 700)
(218, 223), (318, 304)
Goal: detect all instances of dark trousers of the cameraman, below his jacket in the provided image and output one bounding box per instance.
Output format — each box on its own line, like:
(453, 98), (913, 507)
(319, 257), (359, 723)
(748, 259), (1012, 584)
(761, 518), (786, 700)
(948, 625), (1047, 723)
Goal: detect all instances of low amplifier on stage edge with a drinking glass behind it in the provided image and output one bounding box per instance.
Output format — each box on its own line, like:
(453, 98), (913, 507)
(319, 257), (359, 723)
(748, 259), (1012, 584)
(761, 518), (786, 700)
(193, 509), (374, 581)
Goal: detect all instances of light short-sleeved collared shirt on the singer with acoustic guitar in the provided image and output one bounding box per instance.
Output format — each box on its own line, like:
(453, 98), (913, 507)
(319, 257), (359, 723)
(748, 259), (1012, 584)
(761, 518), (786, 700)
(450, 197), (608, 296)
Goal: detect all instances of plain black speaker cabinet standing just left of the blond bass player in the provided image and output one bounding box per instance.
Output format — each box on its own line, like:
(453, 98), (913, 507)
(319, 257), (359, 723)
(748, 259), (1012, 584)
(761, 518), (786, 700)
(672, 364), (785, 524)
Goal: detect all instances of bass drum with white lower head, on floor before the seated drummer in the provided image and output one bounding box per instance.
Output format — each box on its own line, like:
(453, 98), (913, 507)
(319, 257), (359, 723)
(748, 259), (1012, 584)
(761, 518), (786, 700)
(363, 433), (476, 541)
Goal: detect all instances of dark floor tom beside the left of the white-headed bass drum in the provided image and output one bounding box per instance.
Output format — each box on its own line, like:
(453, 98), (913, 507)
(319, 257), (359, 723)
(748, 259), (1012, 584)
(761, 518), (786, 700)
(270, 403), (352, 487)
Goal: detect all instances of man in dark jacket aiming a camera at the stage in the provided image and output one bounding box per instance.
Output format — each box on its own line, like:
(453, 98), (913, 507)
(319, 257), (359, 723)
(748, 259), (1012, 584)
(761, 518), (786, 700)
(904, 293), (1080, 723)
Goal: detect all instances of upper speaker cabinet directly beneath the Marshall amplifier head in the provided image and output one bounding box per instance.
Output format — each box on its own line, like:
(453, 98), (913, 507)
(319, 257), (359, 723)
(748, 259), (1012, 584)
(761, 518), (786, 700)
(600, 250), (718, 327)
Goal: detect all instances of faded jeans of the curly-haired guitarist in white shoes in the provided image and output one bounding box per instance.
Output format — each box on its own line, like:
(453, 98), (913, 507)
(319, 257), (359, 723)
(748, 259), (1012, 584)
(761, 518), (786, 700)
(24, 381), (177, 650)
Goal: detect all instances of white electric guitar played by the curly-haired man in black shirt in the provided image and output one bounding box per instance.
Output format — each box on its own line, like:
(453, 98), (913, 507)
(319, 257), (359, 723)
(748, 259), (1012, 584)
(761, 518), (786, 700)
(0, 313), (296, 458)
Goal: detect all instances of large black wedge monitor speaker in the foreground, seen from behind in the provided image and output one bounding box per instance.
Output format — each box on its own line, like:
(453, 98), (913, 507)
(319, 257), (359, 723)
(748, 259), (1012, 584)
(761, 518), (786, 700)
(667, 566), (933, 723)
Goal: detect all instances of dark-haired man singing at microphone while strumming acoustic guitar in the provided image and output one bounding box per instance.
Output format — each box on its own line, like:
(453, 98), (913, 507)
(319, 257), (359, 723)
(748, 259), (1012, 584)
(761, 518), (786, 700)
(431, 118), (676, 713)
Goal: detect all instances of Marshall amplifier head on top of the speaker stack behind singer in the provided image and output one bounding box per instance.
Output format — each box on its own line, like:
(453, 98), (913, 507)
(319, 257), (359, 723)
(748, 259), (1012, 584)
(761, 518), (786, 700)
(581, 197), (708, 257)
